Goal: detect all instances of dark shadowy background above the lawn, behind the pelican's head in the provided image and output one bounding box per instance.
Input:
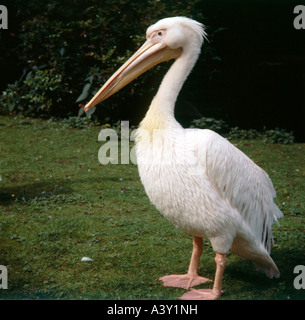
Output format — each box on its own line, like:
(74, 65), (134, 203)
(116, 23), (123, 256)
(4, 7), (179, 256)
(0, 0), (305, 142)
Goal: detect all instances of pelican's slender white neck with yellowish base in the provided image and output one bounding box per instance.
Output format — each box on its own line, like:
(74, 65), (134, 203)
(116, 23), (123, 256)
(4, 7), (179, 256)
(140, 48), (200, 131)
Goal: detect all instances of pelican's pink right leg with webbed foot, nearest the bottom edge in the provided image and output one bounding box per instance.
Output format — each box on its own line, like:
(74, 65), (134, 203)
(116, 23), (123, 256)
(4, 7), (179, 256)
(180, 253), (226, 300)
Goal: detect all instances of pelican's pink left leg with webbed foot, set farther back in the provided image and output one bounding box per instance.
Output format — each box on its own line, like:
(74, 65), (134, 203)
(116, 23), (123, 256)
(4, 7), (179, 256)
(158, 237), (211, 289)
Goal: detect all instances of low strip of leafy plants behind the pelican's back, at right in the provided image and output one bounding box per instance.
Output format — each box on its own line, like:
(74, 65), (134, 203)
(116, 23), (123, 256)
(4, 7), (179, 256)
(191, 117), (294, 144)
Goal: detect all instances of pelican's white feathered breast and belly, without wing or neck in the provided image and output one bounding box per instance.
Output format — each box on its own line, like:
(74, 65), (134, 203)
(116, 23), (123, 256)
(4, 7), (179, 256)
(136, 128), (241, 245)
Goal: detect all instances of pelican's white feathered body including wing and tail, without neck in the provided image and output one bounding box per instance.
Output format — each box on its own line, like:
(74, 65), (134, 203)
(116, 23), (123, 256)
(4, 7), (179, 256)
(136, 128), (281, 272)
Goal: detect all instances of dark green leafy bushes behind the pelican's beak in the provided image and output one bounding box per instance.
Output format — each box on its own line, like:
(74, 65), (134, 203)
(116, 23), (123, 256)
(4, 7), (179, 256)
(0, 0), (208, 117)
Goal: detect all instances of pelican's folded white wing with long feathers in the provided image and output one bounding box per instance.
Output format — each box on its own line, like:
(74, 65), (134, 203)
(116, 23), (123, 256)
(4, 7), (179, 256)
(198, 130), (283, 252)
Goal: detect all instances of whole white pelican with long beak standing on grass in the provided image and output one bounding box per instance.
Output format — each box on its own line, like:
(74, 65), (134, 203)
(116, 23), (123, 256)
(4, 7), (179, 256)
(85, 17), (282, 300)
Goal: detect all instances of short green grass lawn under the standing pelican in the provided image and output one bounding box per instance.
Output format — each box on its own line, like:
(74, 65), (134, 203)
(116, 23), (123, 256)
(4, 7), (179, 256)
(0, 117), (305, 299)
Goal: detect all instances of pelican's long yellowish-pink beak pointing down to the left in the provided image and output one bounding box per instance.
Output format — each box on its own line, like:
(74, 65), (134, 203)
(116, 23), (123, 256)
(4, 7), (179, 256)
(84, 40), (182, 112)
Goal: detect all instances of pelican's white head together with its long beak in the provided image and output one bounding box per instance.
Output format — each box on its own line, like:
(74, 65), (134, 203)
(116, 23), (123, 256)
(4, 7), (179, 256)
(84, 17), (206, 111)
